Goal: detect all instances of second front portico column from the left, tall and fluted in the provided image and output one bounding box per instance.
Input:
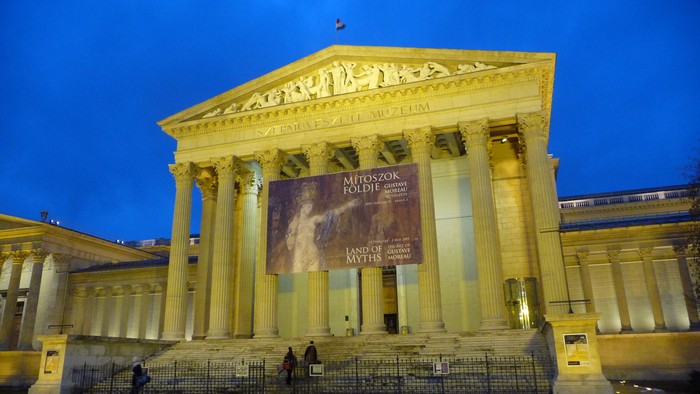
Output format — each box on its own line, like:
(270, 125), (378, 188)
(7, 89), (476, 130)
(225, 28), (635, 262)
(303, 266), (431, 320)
(207, 156), (237, 339)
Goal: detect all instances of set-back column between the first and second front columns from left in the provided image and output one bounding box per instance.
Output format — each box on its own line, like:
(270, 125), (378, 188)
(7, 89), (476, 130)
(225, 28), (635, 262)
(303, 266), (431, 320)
(192, 172), (218, 339)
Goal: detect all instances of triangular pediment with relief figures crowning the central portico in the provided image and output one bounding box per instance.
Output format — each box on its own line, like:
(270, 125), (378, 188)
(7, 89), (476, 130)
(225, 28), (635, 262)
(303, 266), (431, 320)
(159, 45), (555, 132)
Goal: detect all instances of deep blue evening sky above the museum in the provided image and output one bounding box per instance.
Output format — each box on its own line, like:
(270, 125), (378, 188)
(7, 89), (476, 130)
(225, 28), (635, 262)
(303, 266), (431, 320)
(0, 0), (700, 240)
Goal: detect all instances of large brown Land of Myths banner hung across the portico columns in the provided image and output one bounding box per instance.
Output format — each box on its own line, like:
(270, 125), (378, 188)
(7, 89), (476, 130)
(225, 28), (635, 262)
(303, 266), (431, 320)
(267, 164), (423, 274)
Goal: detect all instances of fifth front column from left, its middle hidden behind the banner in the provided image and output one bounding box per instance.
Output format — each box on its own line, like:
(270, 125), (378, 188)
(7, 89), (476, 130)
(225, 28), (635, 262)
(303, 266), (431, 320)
(350, 135), (387, 335)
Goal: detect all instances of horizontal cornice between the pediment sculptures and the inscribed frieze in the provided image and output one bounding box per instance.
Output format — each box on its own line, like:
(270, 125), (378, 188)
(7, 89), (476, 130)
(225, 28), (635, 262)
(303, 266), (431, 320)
(163, 64), (536, 139)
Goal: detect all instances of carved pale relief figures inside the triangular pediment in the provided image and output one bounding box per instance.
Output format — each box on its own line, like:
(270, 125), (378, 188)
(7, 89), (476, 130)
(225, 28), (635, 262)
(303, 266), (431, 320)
(202, 61), (496, 119)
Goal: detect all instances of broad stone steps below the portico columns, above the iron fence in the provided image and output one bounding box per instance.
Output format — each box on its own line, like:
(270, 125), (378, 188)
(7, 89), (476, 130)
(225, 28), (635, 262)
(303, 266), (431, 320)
(147, 330), (549, 364)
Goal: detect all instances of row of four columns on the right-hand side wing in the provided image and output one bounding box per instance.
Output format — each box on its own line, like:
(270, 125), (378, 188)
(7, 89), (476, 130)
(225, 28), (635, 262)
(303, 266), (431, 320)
(576, 245), (700, 333)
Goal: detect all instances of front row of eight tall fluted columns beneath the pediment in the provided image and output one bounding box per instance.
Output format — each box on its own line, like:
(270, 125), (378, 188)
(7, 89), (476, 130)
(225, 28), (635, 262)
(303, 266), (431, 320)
(163, 111), (567, 339)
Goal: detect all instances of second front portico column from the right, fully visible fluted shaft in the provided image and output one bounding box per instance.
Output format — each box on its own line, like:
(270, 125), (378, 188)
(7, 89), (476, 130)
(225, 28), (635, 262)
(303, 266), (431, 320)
(459, 118), (508, 330)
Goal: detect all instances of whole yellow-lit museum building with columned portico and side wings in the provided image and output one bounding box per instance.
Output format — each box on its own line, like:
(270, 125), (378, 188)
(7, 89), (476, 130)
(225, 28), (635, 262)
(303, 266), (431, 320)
(0, 45), (700, 390)
